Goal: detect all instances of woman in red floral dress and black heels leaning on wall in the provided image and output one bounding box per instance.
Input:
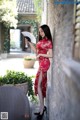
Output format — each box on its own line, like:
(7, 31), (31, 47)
(29, 25), (52, 118)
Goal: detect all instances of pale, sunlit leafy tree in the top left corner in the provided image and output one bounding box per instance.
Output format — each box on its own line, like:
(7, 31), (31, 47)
(0, 0), (18, 28)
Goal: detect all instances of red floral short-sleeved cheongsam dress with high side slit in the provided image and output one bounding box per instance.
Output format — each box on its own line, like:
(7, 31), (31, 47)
(34, 38), (52, 97)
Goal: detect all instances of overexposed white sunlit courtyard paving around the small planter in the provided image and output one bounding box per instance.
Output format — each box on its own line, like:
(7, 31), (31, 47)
(0, 58), (37, 76)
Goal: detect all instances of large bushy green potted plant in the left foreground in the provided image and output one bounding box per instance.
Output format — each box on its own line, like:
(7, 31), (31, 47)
(0, 70), (34, 99)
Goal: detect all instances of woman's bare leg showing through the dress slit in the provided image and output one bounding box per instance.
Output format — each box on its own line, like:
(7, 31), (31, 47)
(38, 71), (44, 114)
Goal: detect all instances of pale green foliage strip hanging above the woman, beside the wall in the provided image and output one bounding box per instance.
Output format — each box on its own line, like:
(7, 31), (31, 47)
(33, 0), (42, 22)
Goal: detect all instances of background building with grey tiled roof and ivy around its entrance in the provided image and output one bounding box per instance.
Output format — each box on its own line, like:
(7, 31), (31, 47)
(0, 0), (38, 52)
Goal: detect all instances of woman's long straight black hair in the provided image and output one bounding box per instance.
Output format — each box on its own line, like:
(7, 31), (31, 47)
(39, 24), (52, 41)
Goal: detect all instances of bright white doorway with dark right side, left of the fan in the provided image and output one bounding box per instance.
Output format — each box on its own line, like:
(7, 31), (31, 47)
(10, 25), (31, 52)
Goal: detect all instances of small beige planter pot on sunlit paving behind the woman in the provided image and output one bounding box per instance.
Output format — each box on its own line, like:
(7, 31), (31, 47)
(23, 56), (36, 68)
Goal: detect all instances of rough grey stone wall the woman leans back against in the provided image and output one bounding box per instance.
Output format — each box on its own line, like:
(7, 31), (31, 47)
(48, 0), (77, 120)
